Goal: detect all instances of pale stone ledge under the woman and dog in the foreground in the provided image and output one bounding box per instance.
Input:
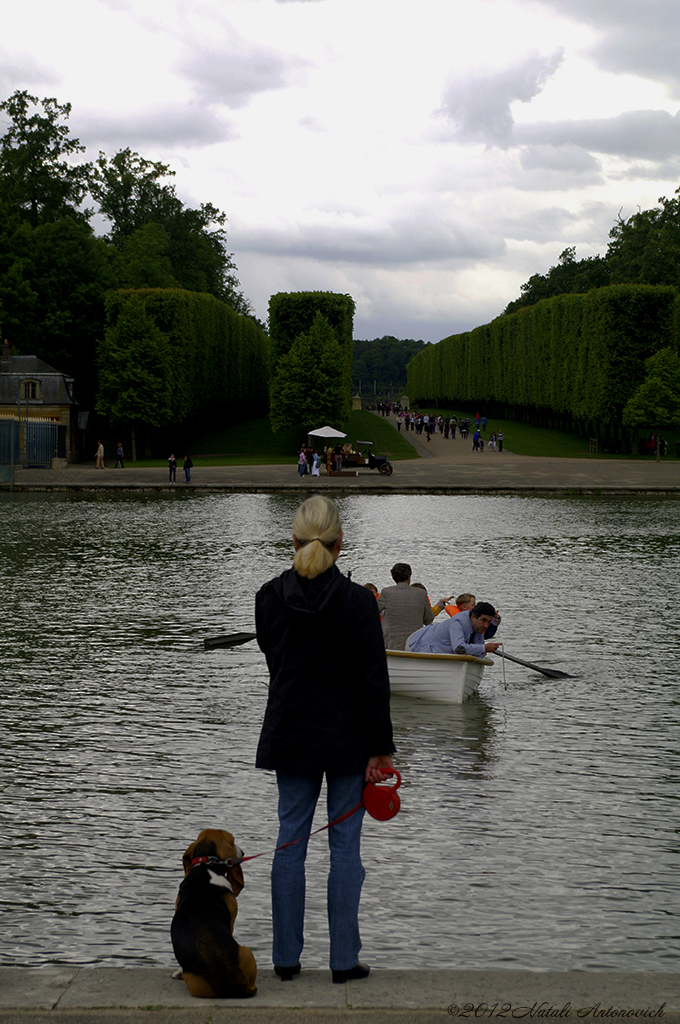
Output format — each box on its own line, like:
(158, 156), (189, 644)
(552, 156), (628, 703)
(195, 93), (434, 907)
(0, 967), (680, 1024)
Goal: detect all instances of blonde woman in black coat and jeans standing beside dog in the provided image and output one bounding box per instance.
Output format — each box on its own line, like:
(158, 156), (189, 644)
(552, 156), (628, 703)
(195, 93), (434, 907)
(255, 495), (394, 983)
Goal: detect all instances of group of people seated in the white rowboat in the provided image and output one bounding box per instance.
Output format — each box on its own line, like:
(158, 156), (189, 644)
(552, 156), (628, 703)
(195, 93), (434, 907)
(365, 562), (501, 657)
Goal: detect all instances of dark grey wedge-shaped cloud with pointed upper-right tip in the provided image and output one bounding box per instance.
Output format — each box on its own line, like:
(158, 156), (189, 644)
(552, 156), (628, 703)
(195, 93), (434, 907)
(440, 49), (564, 147)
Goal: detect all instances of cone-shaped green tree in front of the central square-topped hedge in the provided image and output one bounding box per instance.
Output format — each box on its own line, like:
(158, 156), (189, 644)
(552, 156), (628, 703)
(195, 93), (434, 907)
(269, 312), (346, 433)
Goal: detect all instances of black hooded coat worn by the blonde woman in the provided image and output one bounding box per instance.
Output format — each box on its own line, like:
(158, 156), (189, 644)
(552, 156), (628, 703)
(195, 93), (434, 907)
(255, 565), (394, 775)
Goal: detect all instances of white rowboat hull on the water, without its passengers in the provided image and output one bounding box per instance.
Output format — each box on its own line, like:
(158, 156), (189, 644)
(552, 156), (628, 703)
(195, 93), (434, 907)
(387, 650), (494, 703)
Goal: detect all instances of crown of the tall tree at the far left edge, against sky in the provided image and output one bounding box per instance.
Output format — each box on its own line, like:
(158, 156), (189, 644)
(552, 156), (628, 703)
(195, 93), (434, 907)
(0, 90), (92, 227)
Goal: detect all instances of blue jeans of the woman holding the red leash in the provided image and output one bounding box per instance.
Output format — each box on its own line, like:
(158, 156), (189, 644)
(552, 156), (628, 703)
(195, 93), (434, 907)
(271, 772), (366, 971)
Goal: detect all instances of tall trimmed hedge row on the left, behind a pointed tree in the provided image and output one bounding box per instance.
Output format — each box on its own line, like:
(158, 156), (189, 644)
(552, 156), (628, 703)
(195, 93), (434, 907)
(102, 288), (269, 424)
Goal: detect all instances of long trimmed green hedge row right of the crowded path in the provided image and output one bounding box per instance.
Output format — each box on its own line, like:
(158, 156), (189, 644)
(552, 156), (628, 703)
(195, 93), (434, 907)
(408, 285), (680, 425)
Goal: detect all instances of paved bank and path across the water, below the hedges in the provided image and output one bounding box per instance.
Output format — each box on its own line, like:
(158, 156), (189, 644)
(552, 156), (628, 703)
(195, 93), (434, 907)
(0, 422), (680, 495)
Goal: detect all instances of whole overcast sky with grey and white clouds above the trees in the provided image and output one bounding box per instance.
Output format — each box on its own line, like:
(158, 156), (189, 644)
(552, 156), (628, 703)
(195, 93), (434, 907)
(0, 0), (680, 341)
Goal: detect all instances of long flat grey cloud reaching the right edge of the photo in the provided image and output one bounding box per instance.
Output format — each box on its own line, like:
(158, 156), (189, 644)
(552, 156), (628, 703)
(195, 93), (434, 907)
(514, 111), (680, 161)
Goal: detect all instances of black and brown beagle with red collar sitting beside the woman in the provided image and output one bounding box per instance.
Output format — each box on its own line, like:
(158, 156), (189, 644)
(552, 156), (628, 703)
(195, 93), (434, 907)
(170, 828), (257, 998)
